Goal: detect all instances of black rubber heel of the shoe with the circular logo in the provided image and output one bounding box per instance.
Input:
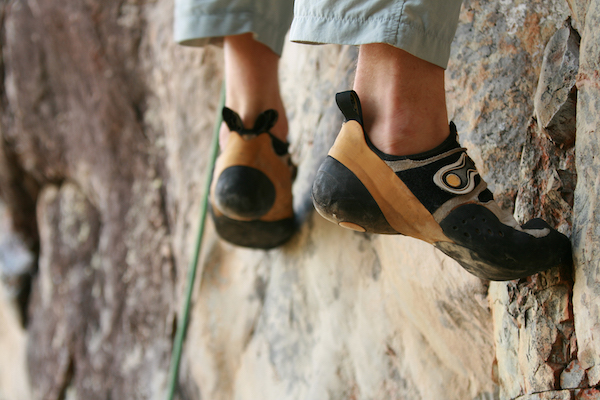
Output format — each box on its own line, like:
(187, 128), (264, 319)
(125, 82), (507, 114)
(312, 156), (398, 234)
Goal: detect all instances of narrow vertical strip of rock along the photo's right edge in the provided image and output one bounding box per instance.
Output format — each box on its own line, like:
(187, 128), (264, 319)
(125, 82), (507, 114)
(573, 1), (600, 385)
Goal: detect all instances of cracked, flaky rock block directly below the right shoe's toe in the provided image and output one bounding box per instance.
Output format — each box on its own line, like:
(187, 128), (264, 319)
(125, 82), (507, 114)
(490, 271), (576, 399)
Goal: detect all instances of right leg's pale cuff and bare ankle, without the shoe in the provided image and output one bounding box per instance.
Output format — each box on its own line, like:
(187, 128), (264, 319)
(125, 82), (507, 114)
(290, 0), (462, 155)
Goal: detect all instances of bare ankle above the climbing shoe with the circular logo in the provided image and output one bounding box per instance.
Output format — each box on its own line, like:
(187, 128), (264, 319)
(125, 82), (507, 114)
(354, 44), (450, 155)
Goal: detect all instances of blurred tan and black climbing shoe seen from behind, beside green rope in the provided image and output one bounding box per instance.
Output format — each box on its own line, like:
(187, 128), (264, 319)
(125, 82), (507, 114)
(210, 107), (295, 249)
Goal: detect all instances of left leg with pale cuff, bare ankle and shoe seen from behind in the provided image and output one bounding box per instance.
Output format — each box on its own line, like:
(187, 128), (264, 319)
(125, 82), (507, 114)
(175, 0), (295, 248)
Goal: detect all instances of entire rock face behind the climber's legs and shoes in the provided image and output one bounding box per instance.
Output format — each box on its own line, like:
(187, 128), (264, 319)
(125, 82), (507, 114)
(0, 0), (600, 400)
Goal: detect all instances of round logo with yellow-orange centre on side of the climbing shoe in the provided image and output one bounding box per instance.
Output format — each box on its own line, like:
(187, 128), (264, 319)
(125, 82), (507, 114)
(433, 153), (479, 194)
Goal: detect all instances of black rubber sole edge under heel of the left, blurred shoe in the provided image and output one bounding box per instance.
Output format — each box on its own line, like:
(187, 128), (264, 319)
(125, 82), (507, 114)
(209, 206), (296, 250)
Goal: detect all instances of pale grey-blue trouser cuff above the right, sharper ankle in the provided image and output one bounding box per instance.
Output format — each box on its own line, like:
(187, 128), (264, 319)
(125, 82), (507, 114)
(290, 0), (462, 69)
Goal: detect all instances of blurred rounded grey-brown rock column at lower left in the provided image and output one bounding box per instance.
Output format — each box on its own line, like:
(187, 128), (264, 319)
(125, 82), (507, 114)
(28, 184), (99, 398)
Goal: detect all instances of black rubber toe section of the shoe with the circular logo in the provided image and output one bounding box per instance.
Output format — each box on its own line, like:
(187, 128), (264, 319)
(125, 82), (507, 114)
(435, 204), (573, 281)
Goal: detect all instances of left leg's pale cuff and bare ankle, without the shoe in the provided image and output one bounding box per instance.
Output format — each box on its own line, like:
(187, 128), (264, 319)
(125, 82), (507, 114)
(174, 0), (293, 145)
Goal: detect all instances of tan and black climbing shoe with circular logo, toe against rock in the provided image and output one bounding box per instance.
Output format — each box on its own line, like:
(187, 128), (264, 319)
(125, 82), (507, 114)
(312, 91), (572, 281)
